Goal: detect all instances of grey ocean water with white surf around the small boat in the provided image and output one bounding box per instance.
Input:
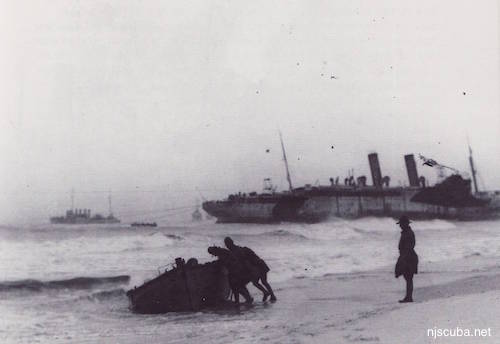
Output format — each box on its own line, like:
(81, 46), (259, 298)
(0, 218), (500, 343)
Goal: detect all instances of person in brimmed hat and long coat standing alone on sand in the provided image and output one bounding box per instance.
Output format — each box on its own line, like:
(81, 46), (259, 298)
(395, 215), (418, 303)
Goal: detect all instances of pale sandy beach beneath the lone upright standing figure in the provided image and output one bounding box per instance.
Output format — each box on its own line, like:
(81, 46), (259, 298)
(193, 256), (500, 343)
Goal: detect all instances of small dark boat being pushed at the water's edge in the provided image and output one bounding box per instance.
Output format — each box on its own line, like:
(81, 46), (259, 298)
(127, 258), (230, 314)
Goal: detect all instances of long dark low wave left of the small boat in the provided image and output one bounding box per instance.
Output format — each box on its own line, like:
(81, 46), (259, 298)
(0, 275), (130, 291)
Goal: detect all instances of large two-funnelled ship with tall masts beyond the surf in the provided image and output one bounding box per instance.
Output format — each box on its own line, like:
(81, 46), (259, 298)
(203, 134), (500, 223)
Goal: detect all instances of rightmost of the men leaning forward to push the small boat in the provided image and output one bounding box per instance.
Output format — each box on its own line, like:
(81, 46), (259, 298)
(224, 237), (276, 302)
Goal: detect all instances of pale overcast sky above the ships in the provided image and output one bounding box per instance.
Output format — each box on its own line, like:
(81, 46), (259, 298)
(0, 0), (500, 223)
